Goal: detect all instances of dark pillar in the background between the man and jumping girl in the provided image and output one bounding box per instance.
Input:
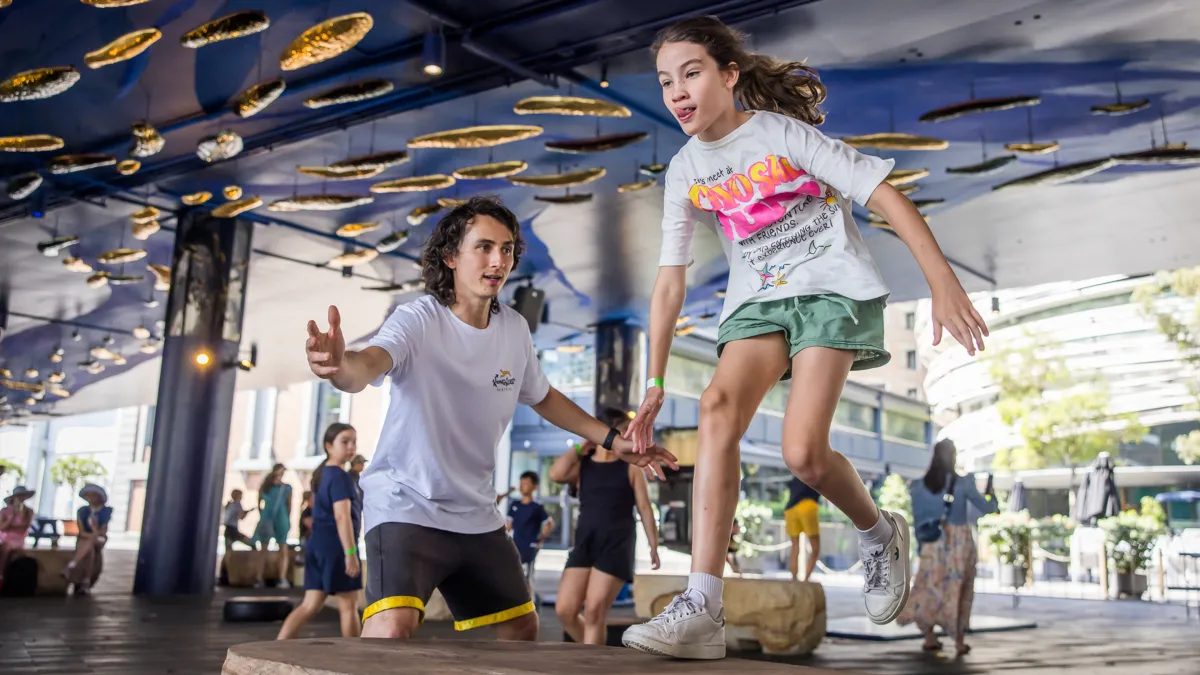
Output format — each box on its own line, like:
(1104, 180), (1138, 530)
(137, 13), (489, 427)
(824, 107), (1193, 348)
(595, 321), (646, 416)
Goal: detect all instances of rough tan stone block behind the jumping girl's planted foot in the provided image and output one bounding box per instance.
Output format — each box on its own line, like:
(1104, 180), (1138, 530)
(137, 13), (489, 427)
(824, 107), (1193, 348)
(634, 574), (827, 655)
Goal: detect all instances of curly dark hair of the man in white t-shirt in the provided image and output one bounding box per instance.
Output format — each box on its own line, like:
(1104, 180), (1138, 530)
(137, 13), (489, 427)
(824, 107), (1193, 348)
(421, 196), (524, 313)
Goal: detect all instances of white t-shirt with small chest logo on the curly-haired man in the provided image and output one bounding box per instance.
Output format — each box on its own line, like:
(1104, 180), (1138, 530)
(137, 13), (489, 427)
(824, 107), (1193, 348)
(359, 295), (550, 534)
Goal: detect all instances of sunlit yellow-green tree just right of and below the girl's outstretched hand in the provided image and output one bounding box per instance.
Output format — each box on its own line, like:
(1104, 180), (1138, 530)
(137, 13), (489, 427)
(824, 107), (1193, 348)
(988, 333), (1146, 471)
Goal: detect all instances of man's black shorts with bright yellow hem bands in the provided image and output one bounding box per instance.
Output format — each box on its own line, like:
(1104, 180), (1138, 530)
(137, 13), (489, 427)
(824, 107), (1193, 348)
(362, 522), (534, 631)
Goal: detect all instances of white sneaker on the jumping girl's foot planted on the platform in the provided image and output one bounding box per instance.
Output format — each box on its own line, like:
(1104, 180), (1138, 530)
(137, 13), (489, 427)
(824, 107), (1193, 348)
(620, 591), (725, 659)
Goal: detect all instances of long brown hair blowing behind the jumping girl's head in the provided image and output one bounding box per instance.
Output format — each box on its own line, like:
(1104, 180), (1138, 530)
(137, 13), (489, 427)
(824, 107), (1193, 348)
(652, 17), (826, 126)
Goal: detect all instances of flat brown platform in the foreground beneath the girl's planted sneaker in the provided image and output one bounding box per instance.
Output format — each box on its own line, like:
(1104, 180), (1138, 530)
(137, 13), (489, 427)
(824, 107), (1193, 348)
(221, 638), (845, 675)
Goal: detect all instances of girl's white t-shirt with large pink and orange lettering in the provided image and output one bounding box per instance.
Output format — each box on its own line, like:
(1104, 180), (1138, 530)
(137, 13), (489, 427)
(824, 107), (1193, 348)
(659, 112), (895, 322)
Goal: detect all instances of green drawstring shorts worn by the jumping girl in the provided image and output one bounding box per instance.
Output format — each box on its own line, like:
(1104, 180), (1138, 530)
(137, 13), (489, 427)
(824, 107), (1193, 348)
(716, 293), (892, 380)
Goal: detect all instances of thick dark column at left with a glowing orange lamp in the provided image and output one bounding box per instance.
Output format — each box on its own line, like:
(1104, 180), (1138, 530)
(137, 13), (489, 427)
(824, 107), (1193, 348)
(133, 211), (253, 596)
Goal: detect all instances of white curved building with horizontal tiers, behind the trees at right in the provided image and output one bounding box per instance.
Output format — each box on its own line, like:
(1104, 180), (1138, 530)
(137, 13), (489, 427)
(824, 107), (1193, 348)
(917, 271), (1200, 521)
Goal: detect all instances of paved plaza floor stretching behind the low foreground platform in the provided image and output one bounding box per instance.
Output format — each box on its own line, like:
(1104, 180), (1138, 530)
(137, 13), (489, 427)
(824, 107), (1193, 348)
(0, 550), (1200, 675)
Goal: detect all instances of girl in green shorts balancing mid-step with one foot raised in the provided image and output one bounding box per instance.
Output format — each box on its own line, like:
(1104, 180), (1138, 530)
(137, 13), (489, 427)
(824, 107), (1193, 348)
(624, 17), (988, 658)
